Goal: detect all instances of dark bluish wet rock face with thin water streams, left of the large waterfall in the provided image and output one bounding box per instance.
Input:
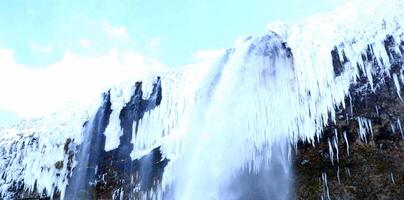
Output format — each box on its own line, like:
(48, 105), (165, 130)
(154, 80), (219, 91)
(65, 77), (168, 199)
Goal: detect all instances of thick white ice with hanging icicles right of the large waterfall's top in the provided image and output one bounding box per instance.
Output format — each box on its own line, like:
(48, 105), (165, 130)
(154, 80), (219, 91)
(268, 0), (404, 140)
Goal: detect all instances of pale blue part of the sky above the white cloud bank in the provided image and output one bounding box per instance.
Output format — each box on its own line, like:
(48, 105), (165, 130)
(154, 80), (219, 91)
(0, 0), (343, 126)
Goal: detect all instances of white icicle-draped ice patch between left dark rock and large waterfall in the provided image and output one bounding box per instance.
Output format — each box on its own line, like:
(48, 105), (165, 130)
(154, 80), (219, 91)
(131, 68), (204, 159)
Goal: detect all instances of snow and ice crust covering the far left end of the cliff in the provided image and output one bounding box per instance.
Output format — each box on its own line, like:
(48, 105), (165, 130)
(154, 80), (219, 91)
(0, 107), (88, 197)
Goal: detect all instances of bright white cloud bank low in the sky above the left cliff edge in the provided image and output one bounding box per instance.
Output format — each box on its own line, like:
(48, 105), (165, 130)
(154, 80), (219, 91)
(0, 49), (163, 117)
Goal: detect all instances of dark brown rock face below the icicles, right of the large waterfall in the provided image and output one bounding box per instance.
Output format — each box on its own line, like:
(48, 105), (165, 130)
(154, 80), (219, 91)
(294, 36), (404, 199)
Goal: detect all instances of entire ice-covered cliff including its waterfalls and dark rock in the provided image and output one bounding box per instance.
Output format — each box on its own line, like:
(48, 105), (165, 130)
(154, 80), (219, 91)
(0, 0), (404, 200)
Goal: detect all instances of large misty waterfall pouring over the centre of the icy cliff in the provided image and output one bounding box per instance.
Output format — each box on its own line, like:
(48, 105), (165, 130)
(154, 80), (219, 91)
(163, 34), (299, 200)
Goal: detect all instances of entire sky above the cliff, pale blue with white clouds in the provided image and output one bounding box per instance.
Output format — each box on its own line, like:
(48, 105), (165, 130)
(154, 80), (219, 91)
(0, 0), (346, 126)
